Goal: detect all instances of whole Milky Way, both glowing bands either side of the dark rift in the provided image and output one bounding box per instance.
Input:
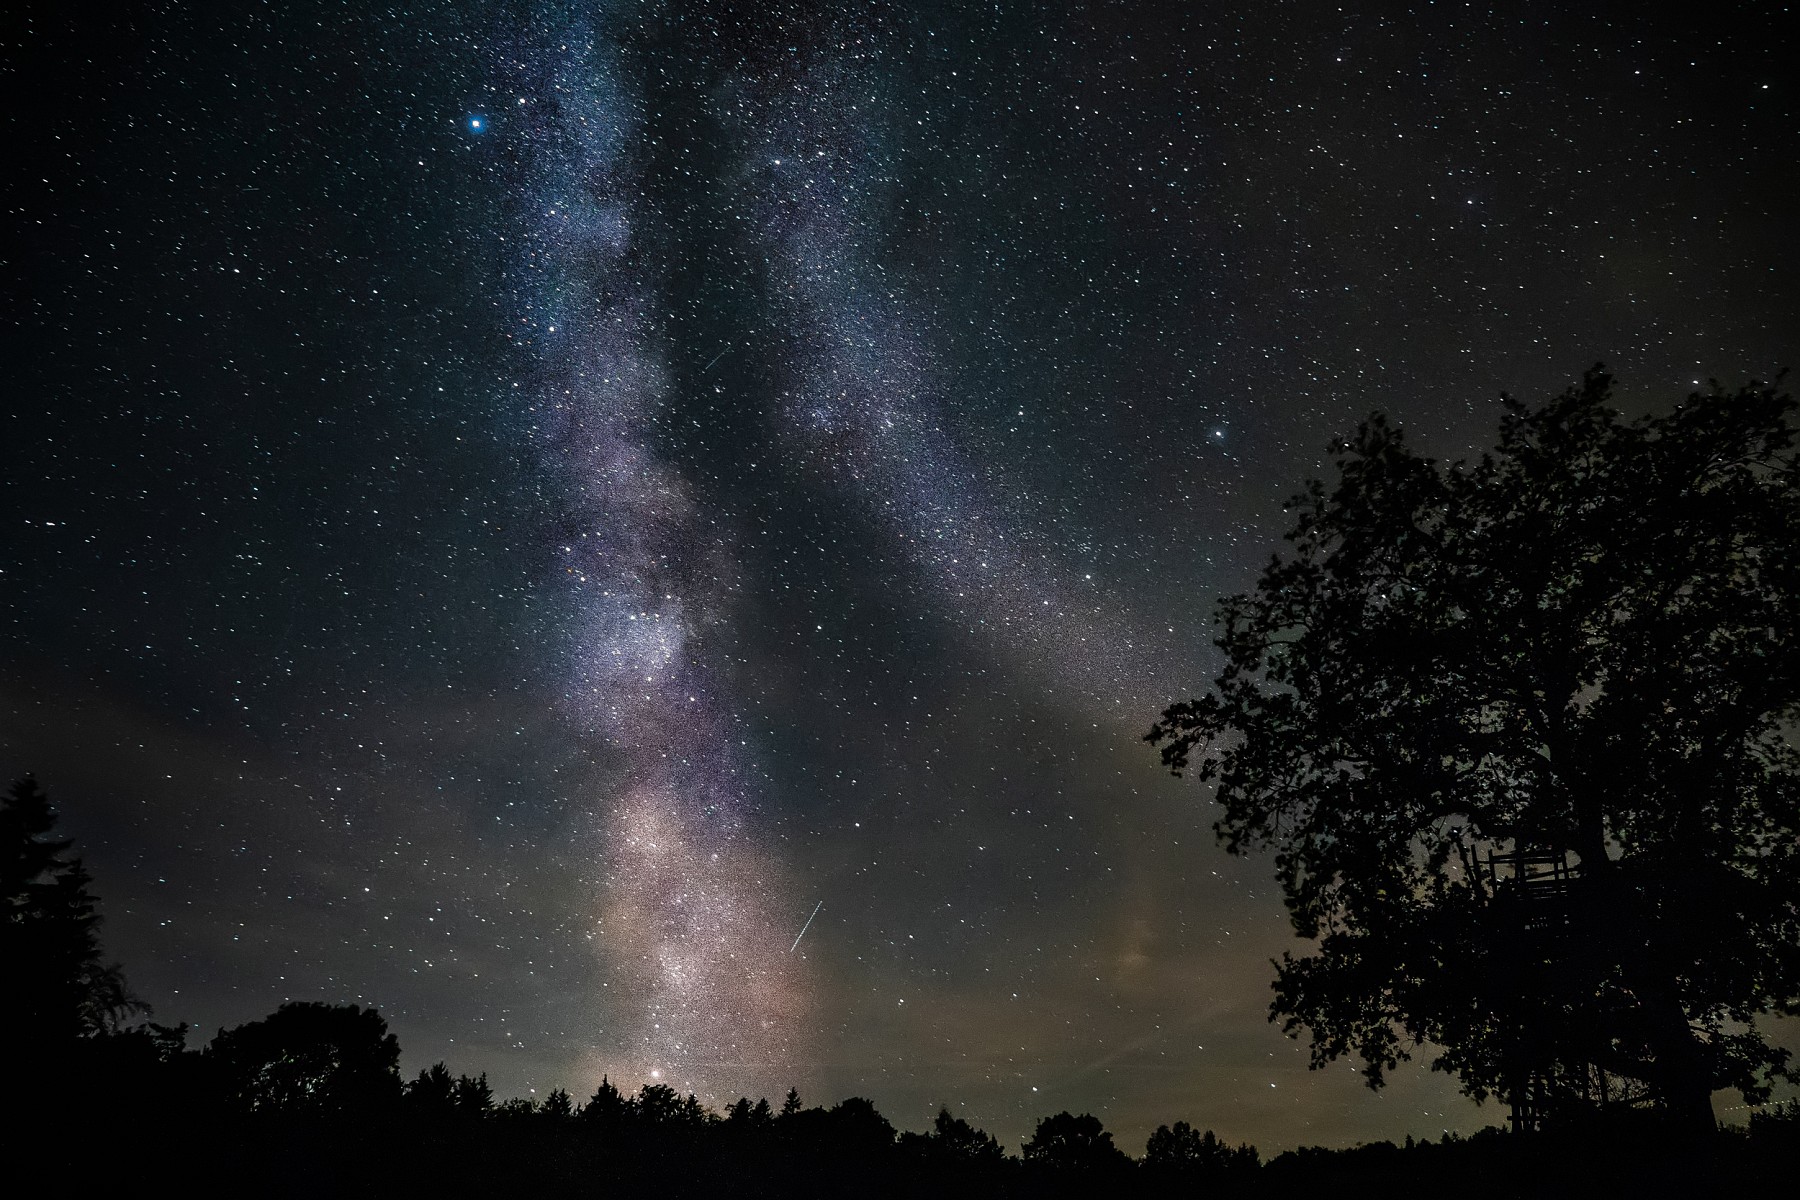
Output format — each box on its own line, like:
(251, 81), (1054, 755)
(511, 2), (1216, 1088)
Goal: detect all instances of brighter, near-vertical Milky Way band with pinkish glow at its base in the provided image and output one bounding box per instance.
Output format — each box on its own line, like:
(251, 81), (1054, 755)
(515, 4), (806, 1090)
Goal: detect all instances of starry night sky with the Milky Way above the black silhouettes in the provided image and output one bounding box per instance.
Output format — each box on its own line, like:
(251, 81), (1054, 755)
(0, 0), (1800, 1151)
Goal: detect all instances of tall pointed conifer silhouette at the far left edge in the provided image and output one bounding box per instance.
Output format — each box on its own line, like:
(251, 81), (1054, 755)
(0, 775), (149, 1074)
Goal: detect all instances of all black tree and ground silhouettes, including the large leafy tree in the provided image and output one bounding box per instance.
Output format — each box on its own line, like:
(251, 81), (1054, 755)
(14, 367), (1800, 1198)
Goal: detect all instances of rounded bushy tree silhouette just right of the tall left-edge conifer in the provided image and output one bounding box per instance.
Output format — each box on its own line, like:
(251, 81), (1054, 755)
(205, 1002), (400, 1114)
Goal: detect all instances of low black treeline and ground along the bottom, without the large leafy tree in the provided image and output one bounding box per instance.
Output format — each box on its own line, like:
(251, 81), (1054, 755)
(0, 779), (1800, 1200)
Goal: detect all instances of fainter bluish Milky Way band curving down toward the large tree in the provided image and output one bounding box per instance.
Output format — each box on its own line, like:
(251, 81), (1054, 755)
(722, 22), (1193, 712)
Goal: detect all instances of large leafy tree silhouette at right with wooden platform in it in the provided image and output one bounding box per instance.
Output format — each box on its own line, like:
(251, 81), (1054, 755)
(1148, 367), (1800, 1130)
